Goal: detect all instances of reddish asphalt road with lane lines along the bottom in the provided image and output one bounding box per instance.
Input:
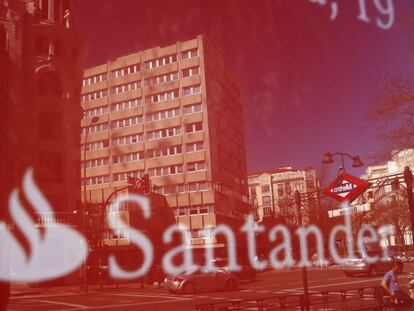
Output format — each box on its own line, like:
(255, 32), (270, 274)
(8, 264), (414, 311)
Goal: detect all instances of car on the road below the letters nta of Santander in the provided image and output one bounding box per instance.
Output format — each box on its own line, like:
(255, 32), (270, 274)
(164, 267), (239, 294)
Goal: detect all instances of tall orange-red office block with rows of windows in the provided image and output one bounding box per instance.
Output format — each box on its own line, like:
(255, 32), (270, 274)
(81, 35), (250, 248)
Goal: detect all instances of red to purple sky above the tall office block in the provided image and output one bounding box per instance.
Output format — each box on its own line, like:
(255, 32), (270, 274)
(74, 0), (414, 184)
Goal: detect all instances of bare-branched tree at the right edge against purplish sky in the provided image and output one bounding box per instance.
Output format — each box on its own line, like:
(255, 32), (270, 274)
(370, 78), (414, 160)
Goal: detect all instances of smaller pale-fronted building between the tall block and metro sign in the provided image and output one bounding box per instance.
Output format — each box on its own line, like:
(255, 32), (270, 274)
(248, 167), (318, 224)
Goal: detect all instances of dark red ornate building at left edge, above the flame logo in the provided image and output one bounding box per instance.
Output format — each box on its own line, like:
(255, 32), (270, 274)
(0, 0), (82, 216)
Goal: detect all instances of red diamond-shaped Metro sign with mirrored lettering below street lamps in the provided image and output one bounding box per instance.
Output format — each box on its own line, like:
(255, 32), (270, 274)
(323, 173), (371, 202)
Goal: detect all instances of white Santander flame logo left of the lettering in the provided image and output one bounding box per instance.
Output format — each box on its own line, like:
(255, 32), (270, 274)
(0, 169), (88, 282)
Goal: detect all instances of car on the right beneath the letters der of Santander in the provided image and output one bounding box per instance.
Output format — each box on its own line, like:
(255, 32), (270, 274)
(341, 251), (404, 276)
